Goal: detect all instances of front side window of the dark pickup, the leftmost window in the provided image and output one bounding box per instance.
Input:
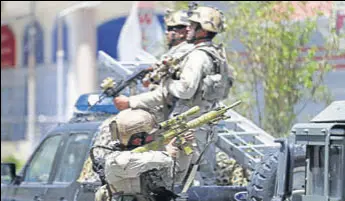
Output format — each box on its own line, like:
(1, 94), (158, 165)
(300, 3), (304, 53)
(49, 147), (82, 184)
(24, 135), (61, 183)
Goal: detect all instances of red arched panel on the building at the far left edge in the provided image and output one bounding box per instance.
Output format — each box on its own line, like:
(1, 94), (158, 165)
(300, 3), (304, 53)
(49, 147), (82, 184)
(1, 25), (16, 69)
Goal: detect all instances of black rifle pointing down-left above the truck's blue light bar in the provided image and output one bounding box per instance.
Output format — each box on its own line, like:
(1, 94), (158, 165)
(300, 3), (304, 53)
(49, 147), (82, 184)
(88, 67), (152, 110)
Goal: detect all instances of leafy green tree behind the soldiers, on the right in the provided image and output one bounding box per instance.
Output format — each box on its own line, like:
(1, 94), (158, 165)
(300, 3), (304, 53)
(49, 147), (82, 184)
(176, 1), (338, 137)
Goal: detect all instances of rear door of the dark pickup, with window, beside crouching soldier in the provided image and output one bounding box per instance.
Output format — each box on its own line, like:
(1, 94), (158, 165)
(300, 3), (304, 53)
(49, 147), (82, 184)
(45, 132), (94, 201)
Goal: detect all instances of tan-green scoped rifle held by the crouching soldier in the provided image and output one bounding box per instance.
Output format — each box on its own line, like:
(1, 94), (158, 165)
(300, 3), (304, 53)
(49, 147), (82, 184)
(132, 101), (242, 155)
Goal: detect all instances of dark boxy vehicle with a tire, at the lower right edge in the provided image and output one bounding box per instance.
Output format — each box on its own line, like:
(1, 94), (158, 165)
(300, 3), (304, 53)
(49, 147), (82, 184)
(248, 101), (345, 201)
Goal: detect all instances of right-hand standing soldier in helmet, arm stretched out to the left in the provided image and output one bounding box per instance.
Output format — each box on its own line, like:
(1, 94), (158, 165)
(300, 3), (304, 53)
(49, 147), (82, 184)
(114, 7), (231, 185)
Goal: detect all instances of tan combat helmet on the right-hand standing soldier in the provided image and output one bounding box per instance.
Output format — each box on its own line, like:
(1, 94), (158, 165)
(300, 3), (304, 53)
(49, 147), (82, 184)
(188, 4), (225, 33)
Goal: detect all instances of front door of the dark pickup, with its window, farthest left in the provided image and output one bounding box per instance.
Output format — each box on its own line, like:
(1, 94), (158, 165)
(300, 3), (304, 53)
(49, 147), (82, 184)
(7, 134), (63, 201)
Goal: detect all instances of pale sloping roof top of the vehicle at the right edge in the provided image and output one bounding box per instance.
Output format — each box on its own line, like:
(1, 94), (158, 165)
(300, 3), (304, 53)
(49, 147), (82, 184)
(311, 100), (345, 123)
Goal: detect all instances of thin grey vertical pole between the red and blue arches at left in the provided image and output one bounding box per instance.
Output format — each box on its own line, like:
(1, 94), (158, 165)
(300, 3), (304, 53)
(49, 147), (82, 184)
(27, 1), (37, 152)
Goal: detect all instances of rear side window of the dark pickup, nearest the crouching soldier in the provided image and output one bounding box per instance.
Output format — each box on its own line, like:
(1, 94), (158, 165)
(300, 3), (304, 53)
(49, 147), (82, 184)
(54, 134), (91, 182)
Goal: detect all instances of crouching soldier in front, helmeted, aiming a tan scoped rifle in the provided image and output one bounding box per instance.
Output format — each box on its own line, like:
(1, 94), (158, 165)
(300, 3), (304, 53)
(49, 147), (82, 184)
(87, 109), (193, 201)
